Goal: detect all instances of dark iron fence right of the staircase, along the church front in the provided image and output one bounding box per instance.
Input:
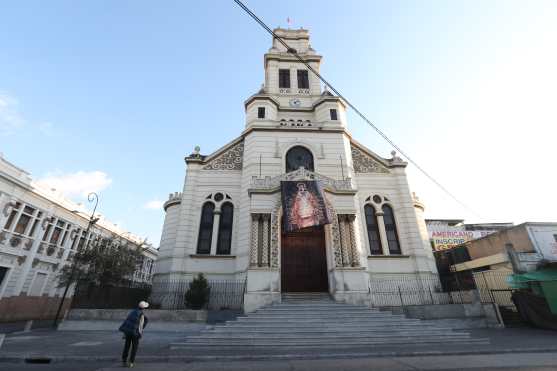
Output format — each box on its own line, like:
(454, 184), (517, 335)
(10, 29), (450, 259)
(369, 275), (474, 307)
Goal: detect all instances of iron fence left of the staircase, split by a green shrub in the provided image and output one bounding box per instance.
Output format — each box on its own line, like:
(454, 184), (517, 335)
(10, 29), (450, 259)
(149, 280), (246, 310)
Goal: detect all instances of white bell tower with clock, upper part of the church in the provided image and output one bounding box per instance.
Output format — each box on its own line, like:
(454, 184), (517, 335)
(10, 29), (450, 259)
(245, 28), (345, 129)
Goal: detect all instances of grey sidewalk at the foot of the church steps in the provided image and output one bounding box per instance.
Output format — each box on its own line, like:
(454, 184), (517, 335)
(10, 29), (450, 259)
(0, 324), (557, 363)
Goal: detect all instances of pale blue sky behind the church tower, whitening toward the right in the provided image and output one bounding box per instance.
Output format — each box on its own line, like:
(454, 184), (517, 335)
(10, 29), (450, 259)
(0, 0), (557, 245)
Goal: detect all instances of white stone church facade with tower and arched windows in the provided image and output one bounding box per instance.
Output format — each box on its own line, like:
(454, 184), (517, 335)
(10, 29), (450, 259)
(154, 28), (437, 312)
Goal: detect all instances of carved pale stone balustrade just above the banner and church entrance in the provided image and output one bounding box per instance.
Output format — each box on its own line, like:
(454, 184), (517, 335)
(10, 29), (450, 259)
(251, 167), (355, 192)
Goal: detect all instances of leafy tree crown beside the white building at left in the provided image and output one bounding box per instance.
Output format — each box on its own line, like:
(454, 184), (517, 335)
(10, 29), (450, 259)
(59, 238), (145, 287)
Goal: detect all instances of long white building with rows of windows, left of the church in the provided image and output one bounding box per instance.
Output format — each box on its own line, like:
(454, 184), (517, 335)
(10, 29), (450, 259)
(0, 156), (158, 322)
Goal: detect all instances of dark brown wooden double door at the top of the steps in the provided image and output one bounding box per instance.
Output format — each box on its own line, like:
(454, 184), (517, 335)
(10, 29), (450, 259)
(281, 227), (329, 292)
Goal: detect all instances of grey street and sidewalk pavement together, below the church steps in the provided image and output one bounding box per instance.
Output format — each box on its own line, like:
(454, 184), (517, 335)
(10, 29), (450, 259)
(0, 325), (557, 371)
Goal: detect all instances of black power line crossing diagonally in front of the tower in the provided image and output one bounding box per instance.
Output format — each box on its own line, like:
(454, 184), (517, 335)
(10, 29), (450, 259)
(234, 0), (481, 218)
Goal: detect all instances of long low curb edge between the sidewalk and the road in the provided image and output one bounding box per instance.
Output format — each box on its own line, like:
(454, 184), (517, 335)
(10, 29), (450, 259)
(0, 347), (557, 363)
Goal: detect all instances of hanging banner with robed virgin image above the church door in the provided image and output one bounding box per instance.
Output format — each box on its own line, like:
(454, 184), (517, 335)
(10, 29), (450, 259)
(281, 180), (331, 232)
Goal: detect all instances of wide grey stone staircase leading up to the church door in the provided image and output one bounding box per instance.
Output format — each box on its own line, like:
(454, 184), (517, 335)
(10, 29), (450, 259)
(171, 293), (488, 358)
